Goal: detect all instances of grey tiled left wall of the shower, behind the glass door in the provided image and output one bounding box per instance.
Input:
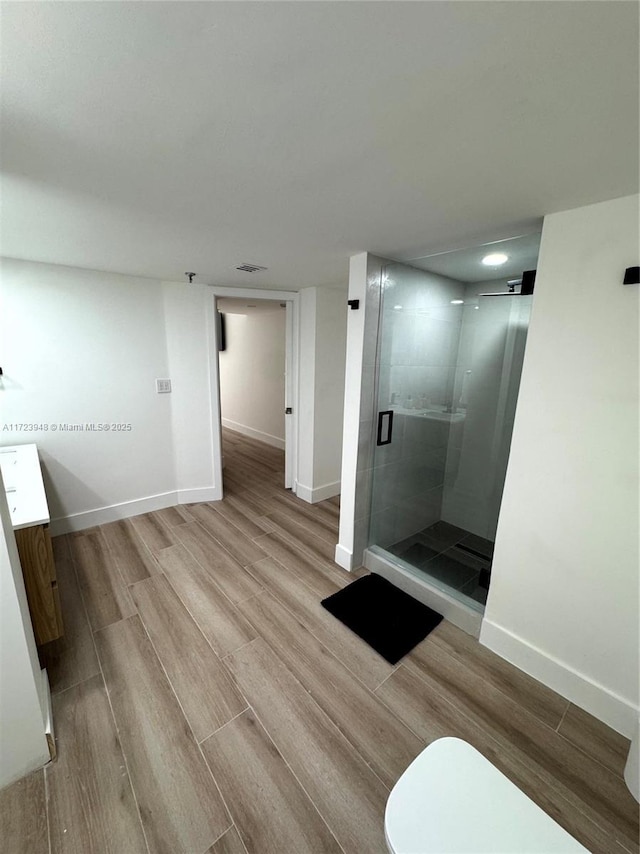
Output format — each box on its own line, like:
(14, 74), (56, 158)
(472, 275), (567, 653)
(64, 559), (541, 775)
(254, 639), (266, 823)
(354, 256), (464, 554)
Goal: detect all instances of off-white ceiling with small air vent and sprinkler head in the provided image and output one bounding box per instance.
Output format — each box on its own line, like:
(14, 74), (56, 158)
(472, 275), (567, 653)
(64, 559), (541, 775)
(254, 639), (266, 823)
(0, 0), (638, 289)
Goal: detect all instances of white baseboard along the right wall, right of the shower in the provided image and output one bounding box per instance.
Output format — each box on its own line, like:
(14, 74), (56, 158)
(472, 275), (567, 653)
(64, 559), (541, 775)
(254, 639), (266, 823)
(480, 618), (638, 738)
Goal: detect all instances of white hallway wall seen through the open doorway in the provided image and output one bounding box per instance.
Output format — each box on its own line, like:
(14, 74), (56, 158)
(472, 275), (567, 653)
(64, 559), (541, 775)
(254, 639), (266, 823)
(220, 305), (286, 448)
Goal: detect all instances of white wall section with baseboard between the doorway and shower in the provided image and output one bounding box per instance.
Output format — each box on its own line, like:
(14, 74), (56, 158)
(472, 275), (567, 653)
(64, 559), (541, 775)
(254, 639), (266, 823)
(296, 288), (348, 502)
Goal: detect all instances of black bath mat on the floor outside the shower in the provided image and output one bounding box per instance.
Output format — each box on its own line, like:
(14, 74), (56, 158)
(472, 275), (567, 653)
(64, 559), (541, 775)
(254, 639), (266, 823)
(322, 573), (442, 664)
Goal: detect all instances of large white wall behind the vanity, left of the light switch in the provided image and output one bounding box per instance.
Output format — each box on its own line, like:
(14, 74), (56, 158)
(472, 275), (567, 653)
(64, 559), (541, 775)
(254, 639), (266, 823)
(0, 259), (174, 521)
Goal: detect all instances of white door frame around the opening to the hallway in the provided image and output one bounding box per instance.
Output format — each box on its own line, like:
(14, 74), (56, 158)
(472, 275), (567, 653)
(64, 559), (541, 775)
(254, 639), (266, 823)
(210, 285), (300, 497)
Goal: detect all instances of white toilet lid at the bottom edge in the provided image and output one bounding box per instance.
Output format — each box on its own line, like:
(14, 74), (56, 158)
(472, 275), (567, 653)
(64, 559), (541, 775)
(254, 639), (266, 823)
(384, 738), (588, 854)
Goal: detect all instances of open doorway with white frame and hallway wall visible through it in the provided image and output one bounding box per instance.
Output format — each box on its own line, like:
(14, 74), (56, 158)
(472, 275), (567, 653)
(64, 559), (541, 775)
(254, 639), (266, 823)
(212, 287), (298, 498)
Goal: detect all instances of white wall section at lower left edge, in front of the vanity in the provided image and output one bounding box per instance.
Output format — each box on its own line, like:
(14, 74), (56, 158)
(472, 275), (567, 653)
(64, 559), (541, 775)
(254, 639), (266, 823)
(0, 474), (49, 789)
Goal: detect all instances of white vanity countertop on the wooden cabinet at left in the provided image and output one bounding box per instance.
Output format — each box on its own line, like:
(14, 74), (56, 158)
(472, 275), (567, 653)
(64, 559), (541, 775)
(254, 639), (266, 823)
(0, 445), (49, 530)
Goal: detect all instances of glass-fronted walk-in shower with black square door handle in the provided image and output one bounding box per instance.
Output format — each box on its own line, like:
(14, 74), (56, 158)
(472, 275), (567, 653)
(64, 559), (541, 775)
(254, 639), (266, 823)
(369, 235), (539, 613)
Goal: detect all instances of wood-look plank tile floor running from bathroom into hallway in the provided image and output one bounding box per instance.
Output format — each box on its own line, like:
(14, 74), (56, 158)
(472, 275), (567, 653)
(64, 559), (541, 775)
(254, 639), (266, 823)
(0, 431), (638, 854)
